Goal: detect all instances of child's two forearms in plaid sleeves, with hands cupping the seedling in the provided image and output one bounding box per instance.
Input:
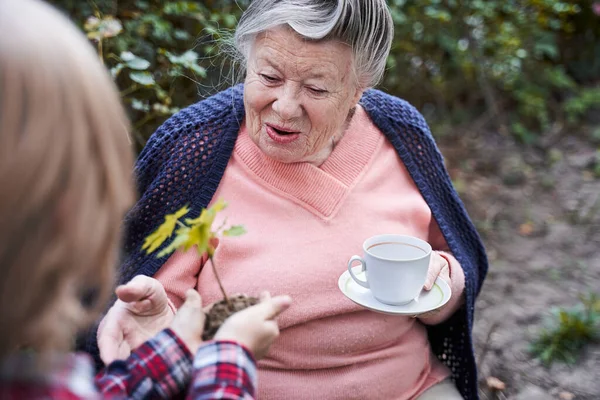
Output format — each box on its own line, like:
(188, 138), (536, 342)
(96, 290), (291, 400)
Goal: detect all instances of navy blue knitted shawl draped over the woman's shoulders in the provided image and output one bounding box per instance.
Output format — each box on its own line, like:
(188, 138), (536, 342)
(120, 85), (488, 399)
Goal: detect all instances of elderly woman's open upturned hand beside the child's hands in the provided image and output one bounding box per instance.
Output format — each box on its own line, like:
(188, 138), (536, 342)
(98, 275), (174, 364)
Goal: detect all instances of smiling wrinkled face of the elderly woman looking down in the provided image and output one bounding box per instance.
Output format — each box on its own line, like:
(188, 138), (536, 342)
(244, 28), (362, 165)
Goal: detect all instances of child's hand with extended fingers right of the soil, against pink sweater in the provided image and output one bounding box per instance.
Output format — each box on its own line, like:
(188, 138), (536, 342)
(214, 292), (292, 360)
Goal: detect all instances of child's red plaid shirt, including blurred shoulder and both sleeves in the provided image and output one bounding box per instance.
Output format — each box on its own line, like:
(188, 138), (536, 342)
(0, 329), (256, 400)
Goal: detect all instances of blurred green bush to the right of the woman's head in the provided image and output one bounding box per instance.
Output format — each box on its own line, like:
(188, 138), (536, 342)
(385, 0), (600, 141)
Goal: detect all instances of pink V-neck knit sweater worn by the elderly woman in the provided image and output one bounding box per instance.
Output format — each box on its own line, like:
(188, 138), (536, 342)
(156, 107), (464, 400)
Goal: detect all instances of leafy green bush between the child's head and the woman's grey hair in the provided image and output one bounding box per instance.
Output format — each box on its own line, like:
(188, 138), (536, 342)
(52, 0), (247, 149)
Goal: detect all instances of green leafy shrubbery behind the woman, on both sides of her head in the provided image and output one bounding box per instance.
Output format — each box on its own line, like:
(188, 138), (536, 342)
(51, 0), (600, 148)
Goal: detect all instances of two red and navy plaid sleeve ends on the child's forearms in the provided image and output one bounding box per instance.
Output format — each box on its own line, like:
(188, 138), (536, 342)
(96, 329), (257, 400)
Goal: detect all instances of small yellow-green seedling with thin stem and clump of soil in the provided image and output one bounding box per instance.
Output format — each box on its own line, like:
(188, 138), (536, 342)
(142, 200), (258, 340)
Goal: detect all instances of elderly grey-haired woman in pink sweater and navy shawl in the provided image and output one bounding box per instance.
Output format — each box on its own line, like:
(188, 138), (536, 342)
(94, 0), (487, 399)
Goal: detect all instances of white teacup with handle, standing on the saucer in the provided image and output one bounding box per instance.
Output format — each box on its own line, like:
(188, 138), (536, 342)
(348, 235), (431, 305)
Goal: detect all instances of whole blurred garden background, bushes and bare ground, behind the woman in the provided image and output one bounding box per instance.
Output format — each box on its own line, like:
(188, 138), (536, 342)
(50, 0), (600, 390)
